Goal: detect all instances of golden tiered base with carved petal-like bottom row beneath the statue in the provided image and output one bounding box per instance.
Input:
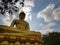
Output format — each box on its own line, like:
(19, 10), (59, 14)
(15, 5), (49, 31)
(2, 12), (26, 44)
(0, 26), (41, 45)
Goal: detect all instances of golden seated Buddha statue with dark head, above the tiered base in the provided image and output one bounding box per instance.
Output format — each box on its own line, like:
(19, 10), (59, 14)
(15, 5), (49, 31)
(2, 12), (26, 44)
(10, 12), (30, 31)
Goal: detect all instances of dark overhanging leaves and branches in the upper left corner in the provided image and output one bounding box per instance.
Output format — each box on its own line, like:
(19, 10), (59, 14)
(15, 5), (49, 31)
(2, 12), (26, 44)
(0, 0), (24, 15)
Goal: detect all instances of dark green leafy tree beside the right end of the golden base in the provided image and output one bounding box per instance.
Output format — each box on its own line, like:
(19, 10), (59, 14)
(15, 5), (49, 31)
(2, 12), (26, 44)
(42, 32), (60, 45)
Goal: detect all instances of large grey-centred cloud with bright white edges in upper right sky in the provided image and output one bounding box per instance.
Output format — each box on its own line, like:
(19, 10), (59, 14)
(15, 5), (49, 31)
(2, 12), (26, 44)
(37, 4), (60, 22)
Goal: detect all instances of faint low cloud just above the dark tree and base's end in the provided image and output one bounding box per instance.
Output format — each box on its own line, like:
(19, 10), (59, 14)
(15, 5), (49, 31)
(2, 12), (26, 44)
(32, 22), (56, 34)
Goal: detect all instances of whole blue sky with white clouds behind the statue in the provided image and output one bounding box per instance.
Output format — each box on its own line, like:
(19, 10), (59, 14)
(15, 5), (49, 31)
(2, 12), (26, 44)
(0, 0), (60, 34)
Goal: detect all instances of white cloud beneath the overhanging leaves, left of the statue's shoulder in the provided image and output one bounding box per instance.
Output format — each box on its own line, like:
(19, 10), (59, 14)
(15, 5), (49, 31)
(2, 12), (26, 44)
(0, 12), (16, 26)
